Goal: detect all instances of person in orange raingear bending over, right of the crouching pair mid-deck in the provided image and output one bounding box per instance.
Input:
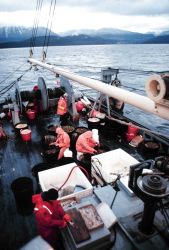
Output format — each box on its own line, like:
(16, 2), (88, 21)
(76, 131), (99, 158)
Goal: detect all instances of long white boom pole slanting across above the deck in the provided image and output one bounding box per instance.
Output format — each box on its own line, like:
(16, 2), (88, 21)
(28, 58), (169, 120)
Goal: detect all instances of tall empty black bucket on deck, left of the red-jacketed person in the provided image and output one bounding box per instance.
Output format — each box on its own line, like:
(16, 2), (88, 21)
(11, 177), (34, 213)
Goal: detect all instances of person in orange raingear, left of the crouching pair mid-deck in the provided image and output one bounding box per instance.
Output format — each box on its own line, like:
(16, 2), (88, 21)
(50, 127), (70, 160)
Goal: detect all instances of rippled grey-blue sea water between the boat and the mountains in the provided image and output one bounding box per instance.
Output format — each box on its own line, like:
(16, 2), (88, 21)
(0, 45), (169, 136)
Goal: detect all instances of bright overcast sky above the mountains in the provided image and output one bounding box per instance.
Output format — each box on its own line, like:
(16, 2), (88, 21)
(0, 0), (169, 33)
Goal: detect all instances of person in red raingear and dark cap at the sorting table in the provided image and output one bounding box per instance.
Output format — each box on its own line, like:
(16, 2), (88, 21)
(32, 188), (71, 249)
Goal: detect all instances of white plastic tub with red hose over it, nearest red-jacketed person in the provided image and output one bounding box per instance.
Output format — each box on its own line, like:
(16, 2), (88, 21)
(38, 163), (93, 200)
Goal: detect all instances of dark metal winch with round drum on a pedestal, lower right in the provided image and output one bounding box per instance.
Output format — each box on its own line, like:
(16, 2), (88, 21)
(129, 159), (169, 235)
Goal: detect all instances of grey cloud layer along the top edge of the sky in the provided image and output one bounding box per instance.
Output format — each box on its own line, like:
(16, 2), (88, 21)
(0, 0), (169, 16)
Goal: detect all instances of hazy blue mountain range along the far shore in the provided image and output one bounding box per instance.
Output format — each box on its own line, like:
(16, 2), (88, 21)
(0, 27), (169, 48)
